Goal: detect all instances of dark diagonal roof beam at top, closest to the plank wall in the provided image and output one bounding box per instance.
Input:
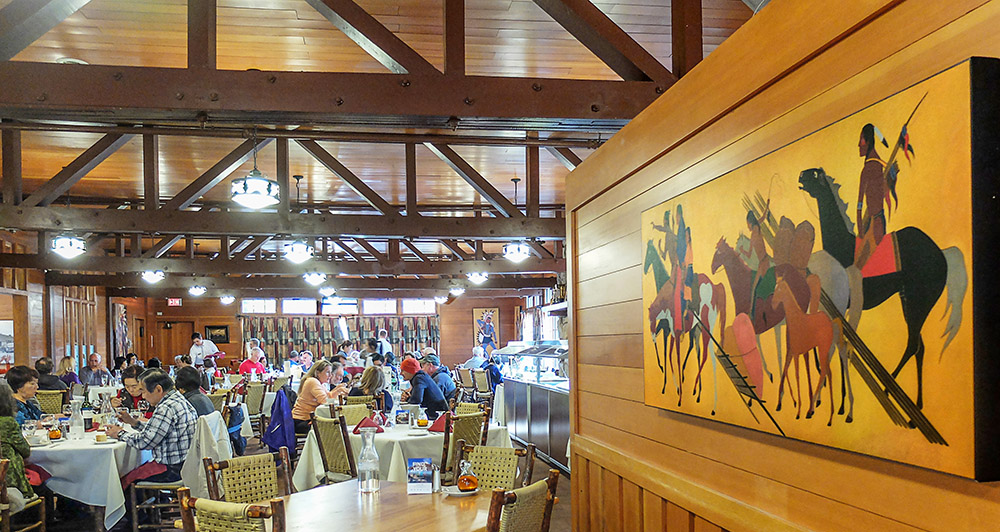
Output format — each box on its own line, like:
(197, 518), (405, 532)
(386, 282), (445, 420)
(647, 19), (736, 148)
(534, 0), (677, 83)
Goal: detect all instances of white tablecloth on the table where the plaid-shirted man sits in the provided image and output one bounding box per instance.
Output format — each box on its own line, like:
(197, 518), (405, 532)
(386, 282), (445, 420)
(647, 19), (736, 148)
(28, 432), (153, 529)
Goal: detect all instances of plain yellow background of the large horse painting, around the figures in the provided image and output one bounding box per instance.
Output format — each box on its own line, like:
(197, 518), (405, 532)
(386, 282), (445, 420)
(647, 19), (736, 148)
(641, 63), (974, 477)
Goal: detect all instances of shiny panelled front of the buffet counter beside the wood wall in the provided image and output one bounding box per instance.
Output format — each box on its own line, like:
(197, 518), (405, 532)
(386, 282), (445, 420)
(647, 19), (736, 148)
(503, 378), (570, 472)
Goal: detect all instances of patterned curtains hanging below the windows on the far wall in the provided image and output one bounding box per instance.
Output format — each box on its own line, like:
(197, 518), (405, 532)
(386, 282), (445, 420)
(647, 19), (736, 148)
(239, 315), (441, 362)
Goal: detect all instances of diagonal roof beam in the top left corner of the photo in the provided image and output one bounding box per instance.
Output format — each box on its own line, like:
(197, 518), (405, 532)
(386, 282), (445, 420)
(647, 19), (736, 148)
(0, 0), (90, 62)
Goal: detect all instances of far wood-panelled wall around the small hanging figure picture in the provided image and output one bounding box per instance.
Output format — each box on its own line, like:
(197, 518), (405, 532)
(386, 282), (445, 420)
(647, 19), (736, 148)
(438, 296), (524, 367)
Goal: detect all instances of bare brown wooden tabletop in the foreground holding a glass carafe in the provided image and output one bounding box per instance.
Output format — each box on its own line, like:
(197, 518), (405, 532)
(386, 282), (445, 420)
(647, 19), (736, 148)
(282, 480), (491, 532)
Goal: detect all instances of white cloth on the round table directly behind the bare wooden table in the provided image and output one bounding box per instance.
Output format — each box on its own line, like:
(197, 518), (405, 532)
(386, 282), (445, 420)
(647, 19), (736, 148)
(292, 425), (512, 491)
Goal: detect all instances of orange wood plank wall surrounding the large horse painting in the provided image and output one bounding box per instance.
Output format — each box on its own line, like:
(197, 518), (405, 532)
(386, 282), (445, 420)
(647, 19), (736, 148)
(566, 0), (1000, 531)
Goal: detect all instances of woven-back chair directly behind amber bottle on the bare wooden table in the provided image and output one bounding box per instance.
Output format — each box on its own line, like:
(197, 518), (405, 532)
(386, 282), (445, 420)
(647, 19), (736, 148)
(455, 440), (535, 490)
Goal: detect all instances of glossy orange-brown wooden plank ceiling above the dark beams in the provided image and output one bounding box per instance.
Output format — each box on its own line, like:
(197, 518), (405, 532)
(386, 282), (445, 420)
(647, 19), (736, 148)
(0, 0), (751, 294)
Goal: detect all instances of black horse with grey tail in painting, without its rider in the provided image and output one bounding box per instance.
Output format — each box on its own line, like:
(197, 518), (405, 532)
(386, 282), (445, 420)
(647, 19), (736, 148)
(799, 168), (968, 409)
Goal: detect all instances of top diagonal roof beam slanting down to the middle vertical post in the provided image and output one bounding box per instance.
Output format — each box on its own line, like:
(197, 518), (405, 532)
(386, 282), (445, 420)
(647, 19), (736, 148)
(306, 0), (440, 74)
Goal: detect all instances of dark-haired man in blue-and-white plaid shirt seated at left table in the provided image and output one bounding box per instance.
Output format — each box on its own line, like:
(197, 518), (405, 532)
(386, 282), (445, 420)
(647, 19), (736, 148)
(107, 369), (198, 482)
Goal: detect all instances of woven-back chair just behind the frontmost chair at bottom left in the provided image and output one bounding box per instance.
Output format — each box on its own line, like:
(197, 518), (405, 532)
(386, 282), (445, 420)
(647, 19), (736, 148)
(202, 447), (292, 504)
